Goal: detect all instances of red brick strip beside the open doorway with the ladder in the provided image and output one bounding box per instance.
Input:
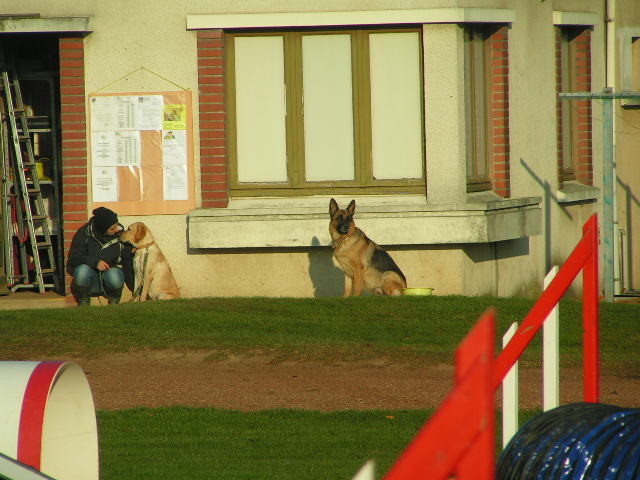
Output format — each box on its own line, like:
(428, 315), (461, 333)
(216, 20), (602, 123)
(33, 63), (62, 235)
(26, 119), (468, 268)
(59, 37), (89, 301)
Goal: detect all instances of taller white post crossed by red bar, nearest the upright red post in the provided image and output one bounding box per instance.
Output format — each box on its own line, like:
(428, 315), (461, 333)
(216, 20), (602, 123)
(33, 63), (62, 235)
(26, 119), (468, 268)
(542, 265), (560, 412)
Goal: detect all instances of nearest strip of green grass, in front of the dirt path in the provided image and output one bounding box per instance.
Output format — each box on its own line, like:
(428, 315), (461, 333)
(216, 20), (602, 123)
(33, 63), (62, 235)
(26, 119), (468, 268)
(98, 407), (430, 480)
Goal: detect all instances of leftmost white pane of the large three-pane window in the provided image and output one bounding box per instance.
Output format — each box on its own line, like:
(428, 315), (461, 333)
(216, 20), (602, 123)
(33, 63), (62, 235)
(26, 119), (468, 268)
(234, 36), (287, 182)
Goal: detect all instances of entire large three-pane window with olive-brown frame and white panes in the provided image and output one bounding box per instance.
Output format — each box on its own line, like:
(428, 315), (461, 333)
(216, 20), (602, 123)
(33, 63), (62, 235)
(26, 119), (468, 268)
(227, 29), (424, 195)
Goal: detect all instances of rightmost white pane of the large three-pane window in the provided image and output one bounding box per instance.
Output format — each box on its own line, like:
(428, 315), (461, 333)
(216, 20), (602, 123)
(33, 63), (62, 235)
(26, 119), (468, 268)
(369, 32), (423, 179)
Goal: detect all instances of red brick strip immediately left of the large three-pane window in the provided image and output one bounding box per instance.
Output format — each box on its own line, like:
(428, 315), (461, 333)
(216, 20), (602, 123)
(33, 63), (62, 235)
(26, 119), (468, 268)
(197, 30), (229, 208)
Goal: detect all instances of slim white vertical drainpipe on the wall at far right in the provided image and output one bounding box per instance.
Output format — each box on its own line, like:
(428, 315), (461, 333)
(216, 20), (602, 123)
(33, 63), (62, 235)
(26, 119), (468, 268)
(604, 0), (621, 295)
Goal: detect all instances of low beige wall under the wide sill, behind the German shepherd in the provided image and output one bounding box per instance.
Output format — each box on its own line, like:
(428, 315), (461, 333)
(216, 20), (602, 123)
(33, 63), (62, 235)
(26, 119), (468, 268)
(129, 247), (461, 297)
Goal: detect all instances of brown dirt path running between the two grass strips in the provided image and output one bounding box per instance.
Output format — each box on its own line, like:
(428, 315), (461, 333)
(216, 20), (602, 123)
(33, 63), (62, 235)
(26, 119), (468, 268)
(52, 351), (640, 411)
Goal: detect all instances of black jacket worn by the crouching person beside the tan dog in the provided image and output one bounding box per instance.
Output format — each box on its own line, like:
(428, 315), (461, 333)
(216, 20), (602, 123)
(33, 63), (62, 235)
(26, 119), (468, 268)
(67, 219), (134, 291)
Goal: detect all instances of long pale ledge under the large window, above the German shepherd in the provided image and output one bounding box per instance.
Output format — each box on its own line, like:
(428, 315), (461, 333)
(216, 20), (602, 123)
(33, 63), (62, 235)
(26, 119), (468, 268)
(188, 196), (541, 249)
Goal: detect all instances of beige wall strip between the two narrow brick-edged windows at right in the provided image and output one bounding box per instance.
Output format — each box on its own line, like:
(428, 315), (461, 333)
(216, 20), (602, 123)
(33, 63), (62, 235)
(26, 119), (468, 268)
(508, 0), (556, 298)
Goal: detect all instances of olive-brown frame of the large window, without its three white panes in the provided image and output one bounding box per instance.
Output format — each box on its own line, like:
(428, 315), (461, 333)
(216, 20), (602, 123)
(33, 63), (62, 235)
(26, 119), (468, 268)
(225, 25), (426, 197)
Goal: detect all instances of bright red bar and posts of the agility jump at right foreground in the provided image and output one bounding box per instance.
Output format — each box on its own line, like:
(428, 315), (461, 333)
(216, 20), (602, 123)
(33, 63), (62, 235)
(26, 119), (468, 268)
(370, 214), (600, 480)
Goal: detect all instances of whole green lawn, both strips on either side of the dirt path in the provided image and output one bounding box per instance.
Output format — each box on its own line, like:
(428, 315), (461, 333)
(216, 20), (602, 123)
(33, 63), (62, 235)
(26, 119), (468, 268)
(0, 296), (640, 480)
